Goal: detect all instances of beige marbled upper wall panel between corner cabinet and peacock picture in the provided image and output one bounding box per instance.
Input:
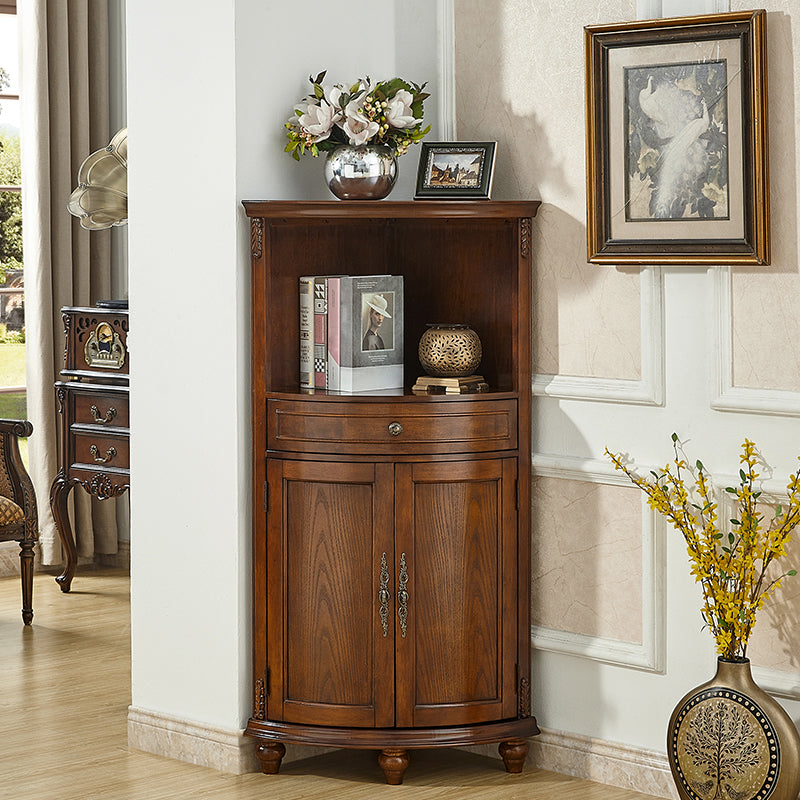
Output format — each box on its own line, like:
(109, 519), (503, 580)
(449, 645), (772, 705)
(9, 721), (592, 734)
(455, 0), (641, 380)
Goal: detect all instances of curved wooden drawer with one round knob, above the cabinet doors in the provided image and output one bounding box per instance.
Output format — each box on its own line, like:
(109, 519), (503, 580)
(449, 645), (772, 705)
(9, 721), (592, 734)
(267, 399), (517, 455)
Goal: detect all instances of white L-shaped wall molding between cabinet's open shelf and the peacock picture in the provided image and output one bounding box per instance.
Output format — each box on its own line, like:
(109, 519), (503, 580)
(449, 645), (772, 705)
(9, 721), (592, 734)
(533, 267), (664, 406)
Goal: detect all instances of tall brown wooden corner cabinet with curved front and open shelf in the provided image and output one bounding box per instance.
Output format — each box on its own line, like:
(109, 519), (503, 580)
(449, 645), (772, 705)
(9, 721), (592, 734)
(244, 201), (539, 784)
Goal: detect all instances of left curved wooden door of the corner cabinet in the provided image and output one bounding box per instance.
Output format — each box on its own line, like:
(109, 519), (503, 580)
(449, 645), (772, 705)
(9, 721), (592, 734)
(266, 460), (394, 727)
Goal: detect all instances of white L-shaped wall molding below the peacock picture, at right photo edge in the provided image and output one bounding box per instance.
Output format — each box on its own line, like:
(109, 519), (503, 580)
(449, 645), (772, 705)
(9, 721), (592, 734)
(709, 267), (800, 417)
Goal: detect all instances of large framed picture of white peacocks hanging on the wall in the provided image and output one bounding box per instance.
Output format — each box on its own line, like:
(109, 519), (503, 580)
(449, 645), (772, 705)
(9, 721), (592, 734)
(585, 10), (770, 265)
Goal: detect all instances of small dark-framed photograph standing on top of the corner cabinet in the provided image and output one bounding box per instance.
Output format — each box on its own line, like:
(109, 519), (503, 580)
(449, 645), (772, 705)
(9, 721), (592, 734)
(414, 142), (497, 200)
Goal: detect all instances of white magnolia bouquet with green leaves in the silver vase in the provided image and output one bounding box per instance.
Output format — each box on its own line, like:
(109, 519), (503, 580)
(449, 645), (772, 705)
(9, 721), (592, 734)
(286, 72), (431, 161)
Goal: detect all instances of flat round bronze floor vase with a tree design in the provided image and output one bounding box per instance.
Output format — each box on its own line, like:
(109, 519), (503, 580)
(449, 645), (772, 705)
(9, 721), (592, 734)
(667, 658), (800, 800)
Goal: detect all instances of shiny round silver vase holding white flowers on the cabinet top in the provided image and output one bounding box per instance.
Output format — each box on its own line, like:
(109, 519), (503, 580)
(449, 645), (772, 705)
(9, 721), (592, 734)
(325, 144), (397, 200)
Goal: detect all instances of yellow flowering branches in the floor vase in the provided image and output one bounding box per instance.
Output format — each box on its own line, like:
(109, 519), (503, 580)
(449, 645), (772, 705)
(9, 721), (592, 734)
(606, 433), (800, 660)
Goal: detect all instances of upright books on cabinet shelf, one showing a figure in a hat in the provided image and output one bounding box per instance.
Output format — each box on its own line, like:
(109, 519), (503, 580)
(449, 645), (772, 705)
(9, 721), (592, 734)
(300, 275), (403, 393)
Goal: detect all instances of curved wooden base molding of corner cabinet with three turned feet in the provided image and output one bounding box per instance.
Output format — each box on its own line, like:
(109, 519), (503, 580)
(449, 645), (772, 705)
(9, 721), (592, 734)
(245, 717), (539, 786)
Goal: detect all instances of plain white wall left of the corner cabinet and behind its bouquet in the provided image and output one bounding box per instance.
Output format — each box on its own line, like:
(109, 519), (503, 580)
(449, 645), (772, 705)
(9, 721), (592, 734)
(127, 0), (446, 766)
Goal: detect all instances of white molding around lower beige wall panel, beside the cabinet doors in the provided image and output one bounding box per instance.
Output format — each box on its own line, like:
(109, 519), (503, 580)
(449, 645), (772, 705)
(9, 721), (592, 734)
(531, 455), (666, 672)
